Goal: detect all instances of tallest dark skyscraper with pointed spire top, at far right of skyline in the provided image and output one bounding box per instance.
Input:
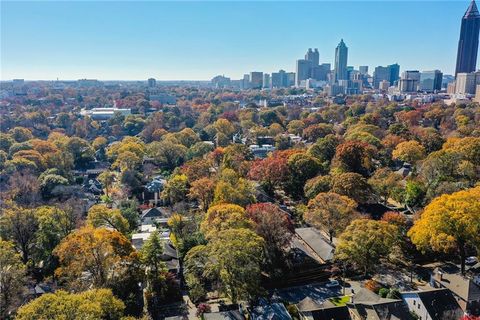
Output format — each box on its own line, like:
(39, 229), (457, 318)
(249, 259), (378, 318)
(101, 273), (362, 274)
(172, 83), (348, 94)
(455, 0), (480, 75)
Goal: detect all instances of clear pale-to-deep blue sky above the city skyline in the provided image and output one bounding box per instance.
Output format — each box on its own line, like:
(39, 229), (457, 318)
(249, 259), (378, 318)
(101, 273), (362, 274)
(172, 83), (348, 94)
(0, 0), (469, 80)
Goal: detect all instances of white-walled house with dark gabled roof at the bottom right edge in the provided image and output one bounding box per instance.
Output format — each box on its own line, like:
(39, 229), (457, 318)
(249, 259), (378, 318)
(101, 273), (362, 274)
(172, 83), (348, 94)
(402, 289), (463, 320)
